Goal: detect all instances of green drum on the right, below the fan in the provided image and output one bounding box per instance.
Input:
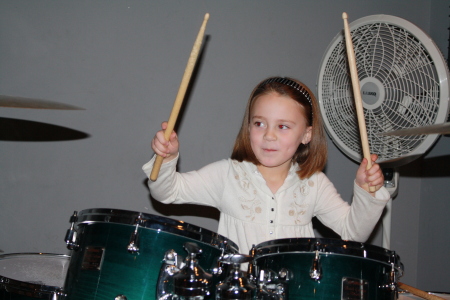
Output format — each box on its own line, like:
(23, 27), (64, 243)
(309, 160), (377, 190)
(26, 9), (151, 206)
(253, 238), (403, 300)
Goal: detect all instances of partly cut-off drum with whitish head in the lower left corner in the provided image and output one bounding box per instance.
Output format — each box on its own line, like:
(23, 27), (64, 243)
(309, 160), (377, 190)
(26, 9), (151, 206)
(0, 253), (69, 300)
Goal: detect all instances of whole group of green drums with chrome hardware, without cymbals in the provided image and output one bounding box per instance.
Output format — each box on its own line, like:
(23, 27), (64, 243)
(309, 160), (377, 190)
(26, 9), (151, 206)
(0, 209), (450, 300)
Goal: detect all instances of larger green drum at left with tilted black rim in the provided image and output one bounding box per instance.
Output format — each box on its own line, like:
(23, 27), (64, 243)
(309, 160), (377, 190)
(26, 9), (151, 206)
(64, 208), (238, 300)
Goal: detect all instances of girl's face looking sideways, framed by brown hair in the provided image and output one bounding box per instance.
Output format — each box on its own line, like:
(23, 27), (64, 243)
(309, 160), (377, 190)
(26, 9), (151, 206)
(249, 92), (312, 170)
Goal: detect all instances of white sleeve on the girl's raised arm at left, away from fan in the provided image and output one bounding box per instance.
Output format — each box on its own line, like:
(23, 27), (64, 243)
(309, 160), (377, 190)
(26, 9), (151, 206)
(142, 155), (228, 209)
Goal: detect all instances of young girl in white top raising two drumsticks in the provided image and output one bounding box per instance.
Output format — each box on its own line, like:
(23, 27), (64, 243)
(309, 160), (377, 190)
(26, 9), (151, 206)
(143, 77), (389, 253)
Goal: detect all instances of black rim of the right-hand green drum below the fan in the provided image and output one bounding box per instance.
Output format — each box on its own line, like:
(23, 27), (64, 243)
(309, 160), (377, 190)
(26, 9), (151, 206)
(255, 238), (403, 271)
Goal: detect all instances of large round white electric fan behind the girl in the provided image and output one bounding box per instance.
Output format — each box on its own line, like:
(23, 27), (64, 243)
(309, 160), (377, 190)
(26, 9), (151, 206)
(317, 15), (449, 248)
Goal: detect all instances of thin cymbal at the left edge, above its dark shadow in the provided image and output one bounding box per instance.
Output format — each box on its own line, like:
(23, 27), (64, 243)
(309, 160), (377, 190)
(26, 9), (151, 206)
(0, 95), (84, 110)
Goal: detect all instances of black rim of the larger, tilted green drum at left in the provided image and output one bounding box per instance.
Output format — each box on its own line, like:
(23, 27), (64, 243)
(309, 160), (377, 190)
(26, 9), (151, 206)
(76, 208), (239, 253)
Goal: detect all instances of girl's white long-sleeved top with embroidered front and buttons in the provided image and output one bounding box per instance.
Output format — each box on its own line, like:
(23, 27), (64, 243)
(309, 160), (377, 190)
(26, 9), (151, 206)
(142, 157), (390, 254)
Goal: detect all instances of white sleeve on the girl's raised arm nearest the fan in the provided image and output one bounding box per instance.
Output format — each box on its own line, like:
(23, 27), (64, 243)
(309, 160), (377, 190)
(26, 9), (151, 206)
(316, 175), (390, 242)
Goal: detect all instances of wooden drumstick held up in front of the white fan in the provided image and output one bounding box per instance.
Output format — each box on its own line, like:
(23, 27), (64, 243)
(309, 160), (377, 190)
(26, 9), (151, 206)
(342, 12), (375, 192)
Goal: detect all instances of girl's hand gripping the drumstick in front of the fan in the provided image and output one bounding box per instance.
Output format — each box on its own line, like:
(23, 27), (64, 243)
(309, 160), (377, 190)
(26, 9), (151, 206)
(356, 154), (384, 196)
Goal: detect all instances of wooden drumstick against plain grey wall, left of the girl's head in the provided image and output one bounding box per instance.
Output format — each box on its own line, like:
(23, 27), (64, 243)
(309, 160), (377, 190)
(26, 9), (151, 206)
(150, 13), (209, 181)
